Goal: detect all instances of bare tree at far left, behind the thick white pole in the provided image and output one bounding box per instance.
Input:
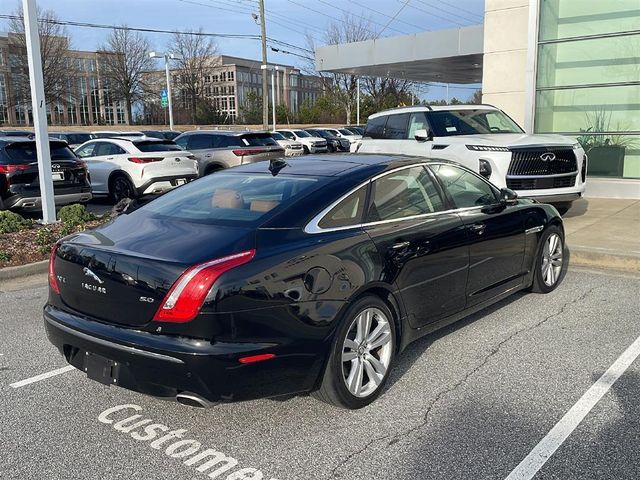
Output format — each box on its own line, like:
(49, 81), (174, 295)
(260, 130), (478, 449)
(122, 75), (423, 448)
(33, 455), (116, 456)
(9, 8), (76, 105)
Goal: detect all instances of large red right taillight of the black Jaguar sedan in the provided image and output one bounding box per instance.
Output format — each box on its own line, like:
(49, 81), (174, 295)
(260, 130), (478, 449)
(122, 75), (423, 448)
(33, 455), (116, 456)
(153, 250), (256, 323)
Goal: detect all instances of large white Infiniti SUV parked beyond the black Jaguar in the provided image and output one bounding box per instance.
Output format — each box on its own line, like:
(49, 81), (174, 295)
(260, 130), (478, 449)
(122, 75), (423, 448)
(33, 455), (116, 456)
(356, 105), (587, 213)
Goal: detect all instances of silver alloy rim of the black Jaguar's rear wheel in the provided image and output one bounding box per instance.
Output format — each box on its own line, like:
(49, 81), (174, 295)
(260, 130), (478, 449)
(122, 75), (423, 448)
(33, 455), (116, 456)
(342, 308), (393, 398)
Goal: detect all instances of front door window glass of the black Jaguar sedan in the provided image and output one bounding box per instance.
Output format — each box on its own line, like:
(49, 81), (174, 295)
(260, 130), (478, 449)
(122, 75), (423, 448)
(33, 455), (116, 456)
(431, 165), (497, 208)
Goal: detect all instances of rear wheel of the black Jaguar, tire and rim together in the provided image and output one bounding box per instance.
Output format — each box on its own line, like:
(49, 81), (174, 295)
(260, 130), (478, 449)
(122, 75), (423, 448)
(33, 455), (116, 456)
(312, 295), (396, 410)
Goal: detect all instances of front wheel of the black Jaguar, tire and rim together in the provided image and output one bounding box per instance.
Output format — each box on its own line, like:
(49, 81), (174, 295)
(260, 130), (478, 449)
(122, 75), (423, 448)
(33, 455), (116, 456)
(530, 225), (568, 293)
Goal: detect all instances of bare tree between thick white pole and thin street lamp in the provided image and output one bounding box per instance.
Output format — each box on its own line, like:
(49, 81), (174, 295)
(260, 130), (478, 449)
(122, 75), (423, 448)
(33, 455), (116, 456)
(98, 27), (154, 123)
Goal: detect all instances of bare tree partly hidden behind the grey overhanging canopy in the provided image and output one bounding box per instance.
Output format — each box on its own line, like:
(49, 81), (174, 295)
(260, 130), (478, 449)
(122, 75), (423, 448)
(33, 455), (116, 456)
(307, 14), (376, 124)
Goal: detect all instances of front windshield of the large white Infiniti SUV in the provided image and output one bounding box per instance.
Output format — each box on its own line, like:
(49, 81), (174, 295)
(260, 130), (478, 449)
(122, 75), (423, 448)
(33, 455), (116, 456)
(428, 109), (524, 137)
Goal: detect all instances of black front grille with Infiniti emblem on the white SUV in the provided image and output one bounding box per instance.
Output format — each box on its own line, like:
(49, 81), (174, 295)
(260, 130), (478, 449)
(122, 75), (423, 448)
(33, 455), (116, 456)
(507, 148), (578, 176)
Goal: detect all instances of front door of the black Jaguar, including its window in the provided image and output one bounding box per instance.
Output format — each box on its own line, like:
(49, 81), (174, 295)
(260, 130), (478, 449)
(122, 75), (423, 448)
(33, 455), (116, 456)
(429, 164), (525, 306)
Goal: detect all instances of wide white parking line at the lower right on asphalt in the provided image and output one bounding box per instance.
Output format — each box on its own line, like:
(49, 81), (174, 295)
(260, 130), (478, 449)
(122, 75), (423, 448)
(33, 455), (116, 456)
(506, 337), (640, 480)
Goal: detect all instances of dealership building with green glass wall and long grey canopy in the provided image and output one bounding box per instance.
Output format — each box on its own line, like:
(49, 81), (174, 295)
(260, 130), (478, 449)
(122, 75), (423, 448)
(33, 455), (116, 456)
(316, 0), (640, 198)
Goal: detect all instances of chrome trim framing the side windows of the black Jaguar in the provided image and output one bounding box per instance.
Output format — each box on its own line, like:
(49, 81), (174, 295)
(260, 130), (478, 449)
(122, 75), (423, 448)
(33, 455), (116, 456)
(303, 162), (487, 234)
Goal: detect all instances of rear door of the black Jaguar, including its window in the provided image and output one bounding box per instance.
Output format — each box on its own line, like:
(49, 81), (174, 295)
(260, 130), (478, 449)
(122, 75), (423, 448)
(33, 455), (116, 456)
(364, 164), (469, 328)
